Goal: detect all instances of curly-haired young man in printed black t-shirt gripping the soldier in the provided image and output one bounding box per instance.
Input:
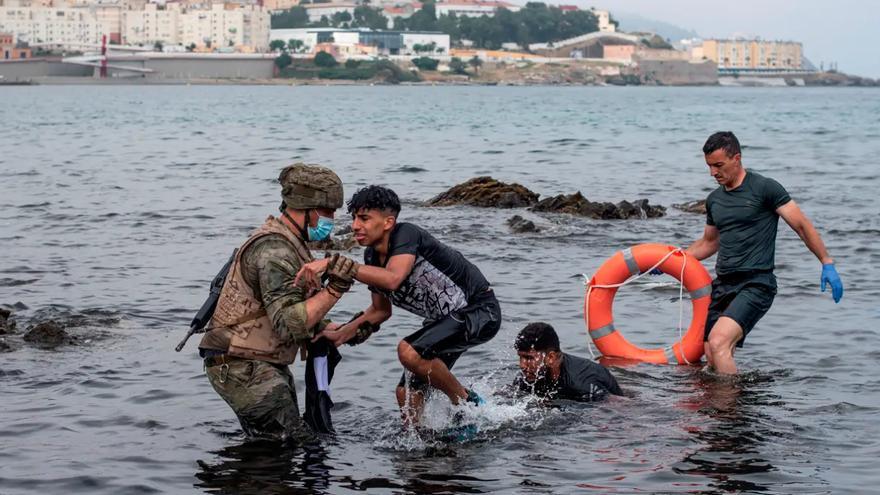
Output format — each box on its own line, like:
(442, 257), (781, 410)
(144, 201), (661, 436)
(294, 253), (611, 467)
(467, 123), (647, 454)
(301, 186), (501, 424)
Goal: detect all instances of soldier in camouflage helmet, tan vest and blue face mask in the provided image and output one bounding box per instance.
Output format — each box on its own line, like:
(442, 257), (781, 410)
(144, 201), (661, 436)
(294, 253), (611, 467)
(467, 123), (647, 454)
(199, 163), (354, 440)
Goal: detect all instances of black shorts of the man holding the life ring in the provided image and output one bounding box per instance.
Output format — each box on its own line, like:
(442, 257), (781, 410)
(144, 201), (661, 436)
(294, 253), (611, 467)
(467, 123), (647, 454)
(703, 272), (776, 347)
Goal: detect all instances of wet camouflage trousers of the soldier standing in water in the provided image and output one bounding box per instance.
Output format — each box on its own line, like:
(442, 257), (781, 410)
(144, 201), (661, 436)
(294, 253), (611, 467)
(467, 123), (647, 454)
(205, 359), (313, 441)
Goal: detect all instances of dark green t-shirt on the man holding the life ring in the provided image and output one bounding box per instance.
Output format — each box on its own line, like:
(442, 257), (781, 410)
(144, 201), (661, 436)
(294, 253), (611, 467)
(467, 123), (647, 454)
(706, 170), (791, 275)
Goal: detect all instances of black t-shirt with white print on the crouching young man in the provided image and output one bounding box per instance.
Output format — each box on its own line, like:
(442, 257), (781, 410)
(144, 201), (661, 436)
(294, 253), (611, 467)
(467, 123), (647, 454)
(364, 222), (489, 321)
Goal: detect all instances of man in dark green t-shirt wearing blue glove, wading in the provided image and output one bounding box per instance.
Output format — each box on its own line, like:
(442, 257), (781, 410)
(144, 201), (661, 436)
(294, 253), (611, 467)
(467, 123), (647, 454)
(687, 132), (843, 374)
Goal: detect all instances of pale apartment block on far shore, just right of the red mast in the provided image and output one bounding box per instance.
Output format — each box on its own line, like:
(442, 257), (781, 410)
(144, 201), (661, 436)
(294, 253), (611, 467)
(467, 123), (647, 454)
(122, 3), (270, 52)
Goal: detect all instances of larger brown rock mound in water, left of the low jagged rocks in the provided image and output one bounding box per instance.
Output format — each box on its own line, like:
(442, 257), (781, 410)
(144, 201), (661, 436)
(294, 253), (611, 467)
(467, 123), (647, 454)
(427, 176), (538, 208)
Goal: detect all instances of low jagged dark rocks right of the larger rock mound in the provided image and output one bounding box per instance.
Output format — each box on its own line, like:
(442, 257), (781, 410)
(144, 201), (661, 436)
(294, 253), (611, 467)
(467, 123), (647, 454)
(531, 191), (666, 220)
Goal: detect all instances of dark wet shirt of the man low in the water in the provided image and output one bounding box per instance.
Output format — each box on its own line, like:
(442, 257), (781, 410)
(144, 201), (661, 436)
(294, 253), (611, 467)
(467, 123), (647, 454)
(513, 352), (623, 402)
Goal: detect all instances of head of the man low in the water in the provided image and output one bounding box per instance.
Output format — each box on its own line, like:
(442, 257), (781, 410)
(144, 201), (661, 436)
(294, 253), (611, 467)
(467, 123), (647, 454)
(513, 322), (562, 383)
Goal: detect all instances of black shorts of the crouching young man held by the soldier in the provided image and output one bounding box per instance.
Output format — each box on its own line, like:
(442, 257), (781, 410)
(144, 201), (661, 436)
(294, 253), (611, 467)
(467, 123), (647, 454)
(398, 290), (501, 390)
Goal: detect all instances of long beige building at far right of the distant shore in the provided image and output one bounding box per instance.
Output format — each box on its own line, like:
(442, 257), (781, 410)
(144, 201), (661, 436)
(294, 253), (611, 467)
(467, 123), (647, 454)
(701, 40), (803, 70)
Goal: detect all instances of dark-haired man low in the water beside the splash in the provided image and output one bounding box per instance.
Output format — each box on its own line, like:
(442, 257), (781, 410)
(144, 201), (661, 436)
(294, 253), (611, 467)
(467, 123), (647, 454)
(513, 322), (623, 401)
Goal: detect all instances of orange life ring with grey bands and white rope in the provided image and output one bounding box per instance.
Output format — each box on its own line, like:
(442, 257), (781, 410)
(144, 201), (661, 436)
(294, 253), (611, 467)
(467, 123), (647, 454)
(584, 244), (712, 364)
